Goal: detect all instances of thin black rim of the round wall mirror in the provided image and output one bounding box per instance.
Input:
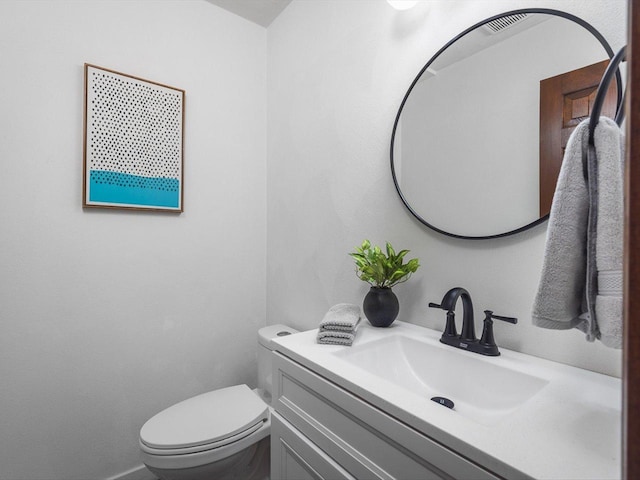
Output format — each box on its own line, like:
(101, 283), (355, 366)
(390, 8), (622, 240)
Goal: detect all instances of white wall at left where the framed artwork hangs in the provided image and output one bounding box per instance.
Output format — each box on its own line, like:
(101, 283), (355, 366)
(0, 0), (266, 480)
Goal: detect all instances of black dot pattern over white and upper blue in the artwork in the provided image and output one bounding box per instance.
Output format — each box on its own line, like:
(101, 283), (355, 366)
(87, 68), (183, 190)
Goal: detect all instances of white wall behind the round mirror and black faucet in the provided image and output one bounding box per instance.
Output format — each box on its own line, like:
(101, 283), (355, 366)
(267, 0), (626, 375)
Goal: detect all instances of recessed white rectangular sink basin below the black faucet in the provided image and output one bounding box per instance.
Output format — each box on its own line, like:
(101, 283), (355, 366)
(334, 335), (549, 425)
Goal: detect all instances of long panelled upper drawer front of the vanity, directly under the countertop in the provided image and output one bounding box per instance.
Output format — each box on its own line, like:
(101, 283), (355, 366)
(273, 352), (500, 480)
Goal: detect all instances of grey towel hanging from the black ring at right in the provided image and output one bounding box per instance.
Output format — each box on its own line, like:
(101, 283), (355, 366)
(532, 117), (624, 348)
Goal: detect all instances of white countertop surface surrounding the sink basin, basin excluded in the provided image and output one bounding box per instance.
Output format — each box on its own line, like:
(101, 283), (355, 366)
(274, 320), (622, 480)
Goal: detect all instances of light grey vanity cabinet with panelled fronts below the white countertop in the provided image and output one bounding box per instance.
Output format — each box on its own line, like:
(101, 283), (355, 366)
(271, 352), (502, 480)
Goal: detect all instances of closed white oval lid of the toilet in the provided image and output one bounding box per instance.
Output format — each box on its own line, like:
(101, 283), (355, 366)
(140, 385), (269, 449)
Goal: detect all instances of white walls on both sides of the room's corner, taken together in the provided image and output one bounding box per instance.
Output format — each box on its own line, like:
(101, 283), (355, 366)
(0, 0), (625, 480)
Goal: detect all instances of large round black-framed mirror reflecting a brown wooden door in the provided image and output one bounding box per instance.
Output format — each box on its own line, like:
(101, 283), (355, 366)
(391, 9), (621, 239)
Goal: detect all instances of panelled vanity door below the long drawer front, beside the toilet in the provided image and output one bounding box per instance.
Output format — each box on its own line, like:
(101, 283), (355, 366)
(271, 412), (355, 480)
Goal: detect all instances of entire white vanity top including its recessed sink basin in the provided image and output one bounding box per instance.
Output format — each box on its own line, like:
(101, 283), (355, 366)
(274, 321), (622, 480)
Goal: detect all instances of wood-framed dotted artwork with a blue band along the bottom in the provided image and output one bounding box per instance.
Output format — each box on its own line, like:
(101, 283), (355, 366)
(82, 63), (185, 212)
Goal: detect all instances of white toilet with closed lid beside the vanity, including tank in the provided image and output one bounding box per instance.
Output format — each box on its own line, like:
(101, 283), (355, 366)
(140, 325), (297, 480)
